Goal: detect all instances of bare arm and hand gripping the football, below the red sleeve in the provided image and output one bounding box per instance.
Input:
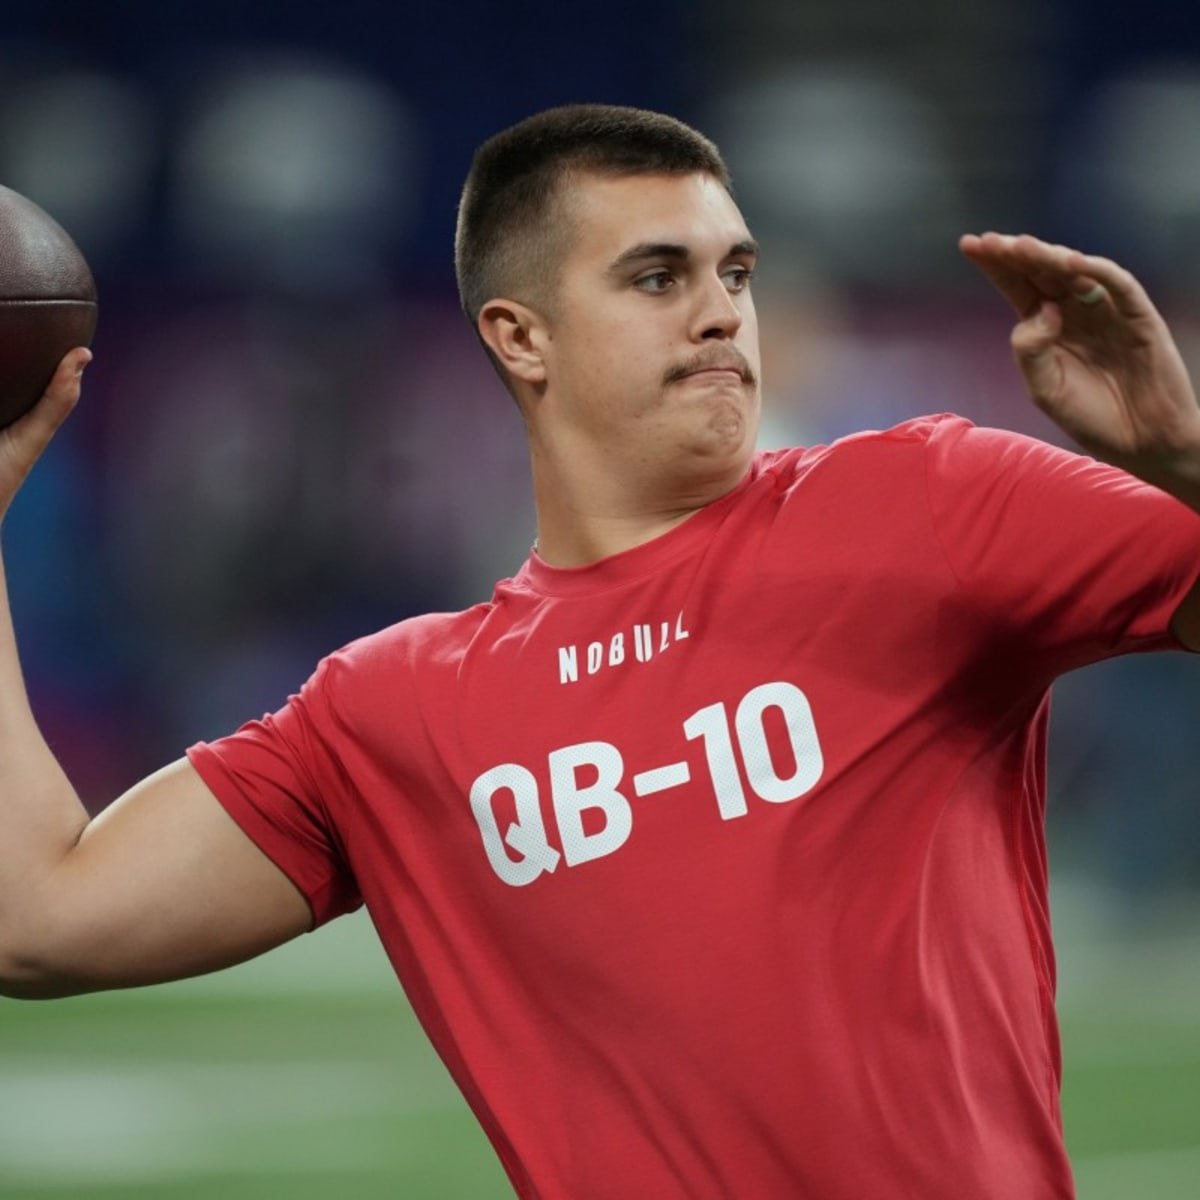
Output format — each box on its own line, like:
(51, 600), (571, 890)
(0, 350), (312, 998)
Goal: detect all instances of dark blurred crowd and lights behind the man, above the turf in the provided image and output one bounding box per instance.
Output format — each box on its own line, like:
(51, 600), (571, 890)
(0, 0), (1200, 896)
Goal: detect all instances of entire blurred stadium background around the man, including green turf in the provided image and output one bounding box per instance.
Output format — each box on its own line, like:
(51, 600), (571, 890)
(0, 0), (1200, 1200)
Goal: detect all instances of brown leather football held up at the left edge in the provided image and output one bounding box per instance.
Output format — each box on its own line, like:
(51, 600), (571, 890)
(0, 186), (97, 427)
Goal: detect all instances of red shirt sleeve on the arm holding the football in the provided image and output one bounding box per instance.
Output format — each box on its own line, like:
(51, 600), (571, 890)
(187, 665), (362, 928)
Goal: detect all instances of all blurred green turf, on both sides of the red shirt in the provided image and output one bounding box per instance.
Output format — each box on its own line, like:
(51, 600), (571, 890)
(0, 892), (1200, 1200)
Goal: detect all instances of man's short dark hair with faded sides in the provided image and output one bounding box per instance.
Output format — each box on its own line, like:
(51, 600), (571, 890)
(455, 104), (731, 328)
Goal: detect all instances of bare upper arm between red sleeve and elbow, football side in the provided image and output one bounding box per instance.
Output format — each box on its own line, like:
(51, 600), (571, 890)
(17, 760), (312, 995)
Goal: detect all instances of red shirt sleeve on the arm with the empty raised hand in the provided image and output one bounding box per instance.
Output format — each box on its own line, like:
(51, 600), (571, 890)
(926, 416), (1200, 673)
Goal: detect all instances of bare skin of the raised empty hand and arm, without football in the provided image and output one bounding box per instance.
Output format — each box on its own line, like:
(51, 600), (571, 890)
(959, 233), (1200, 650)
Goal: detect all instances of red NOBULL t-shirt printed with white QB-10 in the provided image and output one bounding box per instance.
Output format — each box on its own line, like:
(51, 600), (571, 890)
(190, 418), (1200, 1200)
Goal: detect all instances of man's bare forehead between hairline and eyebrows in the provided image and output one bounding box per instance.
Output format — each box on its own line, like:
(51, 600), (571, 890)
(564, 173), (750, 260)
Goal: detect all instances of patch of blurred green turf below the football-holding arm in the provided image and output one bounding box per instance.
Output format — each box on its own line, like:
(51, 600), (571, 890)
(0, 916), (512, 1200)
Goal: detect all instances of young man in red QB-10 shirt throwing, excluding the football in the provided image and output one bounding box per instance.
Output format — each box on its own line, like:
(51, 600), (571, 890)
(0, 106), (1200, 1200)
